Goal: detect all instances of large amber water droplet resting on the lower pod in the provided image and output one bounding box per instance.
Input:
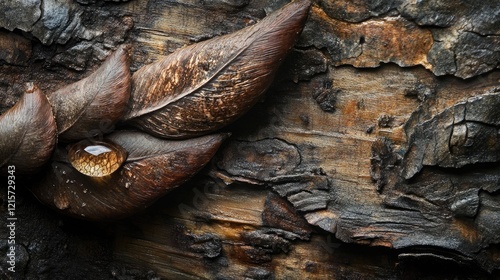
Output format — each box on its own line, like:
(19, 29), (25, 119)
(68, 140), (127, 177)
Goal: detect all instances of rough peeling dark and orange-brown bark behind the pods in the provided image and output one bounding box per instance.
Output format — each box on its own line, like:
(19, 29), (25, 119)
(0, 0), (500, 279)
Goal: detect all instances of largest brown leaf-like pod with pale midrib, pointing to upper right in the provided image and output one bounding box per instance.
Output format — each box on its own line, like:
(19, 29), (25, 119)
(124, 0), (311, 138)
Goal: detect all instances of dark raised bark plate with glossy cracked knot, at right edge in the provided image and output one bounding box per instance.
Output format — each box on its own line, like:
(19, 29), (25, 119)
(403, 93), (500, 179)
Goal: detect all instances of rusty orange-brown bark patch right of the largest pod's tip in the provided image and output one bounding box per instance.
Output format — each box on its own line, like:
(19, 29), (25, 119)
(309, 7), (434, 69)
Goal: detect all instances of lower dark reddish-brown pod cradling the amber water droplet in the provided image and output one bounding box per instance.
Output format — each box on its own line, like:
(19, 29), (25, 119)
(31, 131), (227, 220)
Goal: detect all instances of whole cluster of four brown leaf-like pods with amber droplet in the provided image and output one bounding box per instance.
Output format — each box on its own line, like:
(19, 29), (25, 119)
(0, 0), (311, 220)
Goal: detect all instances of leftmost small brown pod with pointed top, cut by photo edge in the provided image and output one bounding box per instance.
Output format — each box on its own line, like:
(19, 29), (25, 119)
(0, 83), (57, 173)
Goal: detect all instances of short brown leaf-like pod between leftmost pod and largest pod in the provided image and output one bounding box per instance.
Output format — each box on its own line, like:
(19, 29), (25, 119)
(49, 47), (130, 141)
